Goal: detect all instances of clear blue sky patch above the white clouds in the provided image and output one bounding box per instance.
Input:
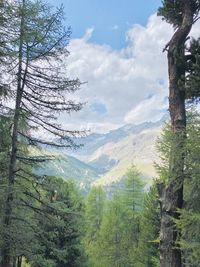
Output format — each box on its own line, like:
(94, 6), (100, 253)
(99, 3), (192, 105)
(48, 0), (161, 49)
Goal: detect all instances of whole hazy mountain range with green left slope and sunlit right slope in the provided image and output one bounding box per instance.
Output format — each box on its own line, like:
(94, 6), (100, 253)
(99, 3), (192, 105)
(38, 118), (166, 191)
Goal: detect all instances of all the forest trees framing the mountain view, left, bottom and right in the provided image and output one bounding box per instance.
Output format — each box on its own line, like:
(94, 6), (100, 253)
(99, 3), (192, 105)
(0, 0), (200, 267)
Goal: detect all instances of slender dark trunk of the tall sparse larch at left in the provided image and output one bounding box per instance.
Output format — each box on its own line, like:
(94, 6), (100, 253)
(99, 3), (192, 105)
(1, 0), (25, 267)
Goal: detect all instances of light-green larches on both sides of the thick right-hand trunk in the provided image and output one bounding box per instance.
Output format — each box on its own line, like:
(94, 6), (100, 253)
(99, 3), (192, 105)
(84, 112), (200, 267)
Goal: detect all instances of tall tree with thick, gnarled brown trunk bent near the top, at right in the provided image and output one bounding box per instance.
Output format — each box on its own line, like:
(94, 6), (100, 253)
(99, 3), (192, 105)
(158, 0), (200, 267)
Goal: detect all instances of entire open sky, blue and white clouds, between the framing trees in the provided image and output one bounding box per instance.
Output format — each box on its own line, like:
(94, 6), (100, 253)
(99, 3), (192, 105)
(49, 0), (200, 133)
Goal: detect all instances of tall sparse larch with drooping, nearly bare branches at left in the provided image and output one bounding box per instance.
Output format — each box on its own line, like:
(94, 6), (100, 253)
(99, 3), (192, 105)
(0, 0), (82, 267)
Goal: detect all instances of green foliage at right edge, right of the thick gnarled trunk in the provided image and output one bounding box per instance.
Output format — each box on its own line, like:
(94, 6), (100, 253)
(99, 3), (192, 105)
(178, 113), (200, 267)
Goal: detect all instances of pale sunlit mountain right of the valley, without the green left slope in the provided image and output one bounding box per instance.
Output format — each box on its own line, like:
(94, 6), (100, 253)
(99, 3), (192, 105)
(69, 118), (166, 191)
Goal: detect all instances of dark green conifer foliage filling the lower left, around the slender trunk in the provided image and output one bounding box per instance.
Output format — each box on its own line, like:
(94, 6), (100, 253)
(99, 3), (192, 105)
(0, 117), (86, 267)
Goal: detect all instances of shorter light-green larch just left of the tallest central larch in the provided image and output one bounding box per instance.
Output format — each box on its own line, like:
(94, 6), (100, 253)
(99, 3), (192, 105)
(96, 194), (129, 267)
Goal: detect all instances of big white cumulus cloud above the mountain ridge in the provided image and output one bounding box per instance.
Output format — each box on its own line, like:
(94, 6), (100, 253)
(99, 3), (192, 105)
(61, 15), (200, 131)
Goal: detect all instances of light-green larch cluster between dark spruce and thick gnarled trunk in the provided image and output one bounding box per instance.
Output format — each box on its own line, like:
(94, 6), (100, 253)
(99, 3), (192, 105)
(85, 167), (160, 267)
